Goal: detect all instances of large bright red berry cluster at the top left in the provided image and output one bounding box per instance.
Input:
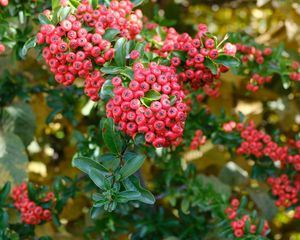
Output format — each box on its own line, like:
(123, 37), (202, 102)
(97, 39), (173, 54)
(37, 0), (142, 100)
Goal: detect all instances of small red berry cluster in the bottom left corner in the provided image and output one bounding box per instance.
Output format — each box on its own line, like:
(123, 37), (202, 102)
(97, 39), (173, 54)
(12, 182), (55, 225)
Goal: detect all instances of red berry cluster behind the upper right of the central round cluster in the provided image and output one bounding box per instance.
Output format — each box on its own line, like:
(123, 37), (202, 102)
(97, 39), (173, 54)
(145, 24), (236, 97)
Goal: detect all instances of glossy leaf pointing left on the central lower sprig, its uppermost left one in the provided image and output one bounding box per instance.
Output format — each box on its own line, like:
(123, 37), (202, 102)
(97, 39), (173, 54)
(72, 156), (108, 174)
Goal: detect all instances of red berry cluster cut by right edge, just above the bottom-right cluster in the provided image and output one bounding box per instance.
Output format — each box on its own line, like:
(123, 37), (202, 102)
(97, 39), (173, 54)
(267, 174), (300, 218)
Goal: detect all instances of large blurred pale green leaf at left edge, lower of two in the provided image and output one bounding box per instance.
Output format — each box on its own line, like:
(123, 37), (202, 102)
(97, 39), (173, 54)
(0, 130), (28, 185)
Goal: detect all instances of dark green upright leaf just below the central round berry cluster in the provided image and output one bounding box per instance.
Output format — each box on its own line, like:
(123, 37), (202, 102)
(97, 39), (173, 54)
(102, 118), (123, 155)
